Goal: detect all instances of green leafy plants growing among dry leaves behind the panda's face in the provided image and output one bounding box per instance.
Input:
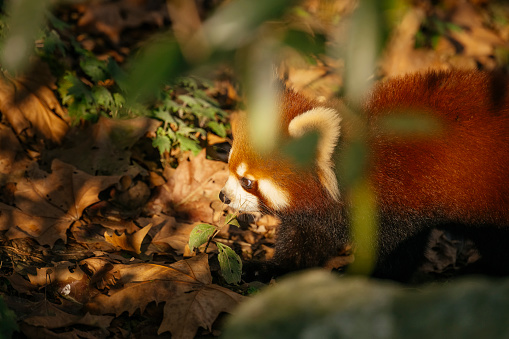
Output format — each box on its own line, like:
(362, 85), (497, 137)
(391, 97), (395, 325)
(33, 16), (228, 154)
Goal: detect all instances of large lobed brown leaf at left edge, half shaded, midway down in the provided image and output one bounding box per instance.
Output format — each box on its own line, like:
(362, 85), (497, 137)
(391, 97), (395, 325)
(0, 160), (119, 246)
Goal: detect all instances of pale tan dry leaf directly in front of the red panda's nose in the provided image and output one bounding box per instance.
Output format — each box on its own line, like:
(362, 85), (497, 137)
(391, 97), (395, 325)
(153, 150), (228, 223)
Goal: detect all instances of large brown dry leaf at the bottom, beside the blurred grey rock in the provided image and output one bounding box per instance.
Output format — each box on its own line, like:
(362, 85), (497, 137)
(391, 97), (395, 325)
(87, 255), (245, 339)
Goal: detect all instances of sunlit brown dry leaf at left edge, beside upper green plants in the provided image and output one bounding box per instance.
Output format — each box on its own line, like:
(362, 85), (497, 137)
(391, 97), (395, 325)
(0, 63), (69, 143)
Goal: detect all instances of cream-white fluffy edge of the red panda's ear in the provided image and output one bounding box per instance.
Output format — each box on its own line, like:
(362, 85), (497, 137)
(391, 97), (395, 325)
(288, 107), (341, 200)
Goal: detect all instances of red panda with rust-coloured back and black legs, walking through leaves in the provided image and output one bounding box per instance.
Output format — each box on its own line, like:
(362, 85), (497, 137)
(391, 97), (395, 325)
(220, 71), (509, 281)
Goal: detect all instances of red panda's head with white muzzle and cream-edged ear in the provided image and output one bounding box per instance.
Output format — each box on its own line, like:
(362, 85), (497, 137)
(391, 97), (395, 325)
(220, 90), (341, 213)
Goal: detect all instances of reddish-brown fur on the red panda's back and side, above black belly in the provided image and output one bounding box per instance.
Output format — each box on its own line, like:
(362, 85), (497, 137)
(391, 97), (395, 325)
(367, 72), (509, 225)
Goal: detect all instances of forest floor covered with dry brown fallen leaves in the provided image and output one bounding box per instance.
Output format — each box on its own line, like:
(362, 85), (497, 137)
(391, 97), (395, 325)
(0, 0), (509, 338)
